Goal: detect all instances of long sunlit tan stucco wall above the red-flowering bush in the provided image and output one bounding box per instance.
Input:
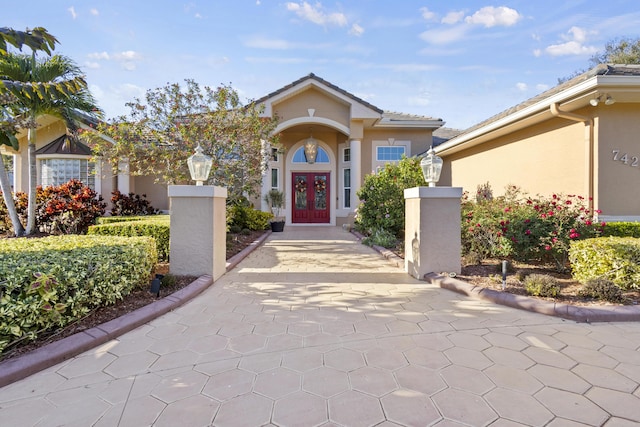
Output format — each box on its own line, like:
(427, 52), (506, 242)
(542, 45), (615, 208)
(438, 119), (588, 201)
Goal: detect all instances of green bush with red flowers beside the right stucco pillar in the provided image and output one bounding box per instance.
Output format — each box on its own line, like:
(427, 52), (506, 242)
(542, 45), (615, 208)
(461, 183), (605, 271)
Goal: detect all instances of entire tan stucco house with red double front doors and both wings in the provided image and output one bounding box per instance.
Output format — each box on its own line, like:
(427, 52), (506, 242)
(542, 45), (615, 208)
(2, 64), (640, 226)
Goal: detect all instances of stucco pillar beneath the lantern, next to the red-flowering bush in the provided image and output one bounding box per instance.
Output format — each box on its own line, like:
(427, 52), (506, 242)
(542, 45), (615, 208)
(404, 187), (462, 280)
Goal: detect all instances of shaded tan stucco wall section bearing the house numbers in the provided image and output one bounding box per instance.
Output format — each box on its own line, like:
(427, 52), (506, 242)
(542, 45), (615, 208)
(595, 104), (640, 216)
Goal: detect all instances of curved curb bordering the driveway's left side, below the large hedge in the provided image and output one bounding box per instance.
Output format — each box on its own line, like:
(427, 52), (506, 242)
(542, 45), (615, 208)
(0, 232), (271, 388)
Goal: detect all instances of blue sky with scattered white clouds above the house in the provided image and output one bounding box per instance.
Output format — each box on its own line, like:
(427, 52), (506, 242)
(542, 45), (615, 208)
(5, 0), (640, 129)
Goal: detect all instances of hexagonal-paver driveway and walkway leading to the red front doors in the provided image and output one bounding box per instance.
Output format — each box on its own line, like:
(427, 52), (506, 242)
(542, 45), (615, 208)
(0, 227), (640, 427)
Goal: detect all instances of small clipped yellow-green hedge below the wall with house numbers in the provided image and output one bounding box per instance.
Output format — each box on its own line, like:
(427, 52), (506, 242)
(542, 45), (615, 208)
(569, 237), (640, 289)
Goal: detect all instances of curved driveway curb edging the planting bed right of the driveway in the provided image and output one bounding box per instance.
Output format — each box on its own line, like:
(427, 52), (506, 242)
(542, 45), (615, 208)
(424, 273), (640, 323)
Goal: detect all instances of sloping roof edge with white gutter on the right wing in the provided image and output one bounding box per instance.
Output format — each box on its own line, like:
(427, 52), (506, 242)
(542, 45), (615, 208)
(436, 64), (640, 154)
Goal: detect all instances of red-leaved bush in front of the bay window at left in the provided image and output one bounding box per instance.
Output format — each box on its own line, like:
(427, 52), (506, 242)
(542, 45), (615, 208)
(15, 180), (106, 234)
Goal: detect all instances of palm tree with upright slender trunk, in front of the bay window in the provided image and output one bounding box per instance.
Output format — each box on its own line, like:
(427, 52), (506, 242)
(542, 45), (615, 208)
(0, 51), (102, 235)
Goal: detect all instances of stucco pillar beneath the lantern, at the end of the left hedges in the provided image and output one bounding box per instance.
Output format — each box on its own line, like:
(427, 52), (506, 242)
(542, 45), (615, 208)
(169, 185), (227, 280)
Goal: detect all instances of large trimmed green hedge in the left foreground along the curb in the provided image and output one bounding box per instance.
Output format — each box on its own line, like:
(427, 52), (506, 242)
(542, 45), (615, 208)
(0, 236), (158, 352)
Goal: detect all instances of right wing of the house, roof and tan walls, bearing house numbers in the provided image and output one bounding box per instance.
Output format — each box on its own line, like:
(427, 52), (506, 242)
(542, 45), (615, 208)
(435, 64), (640, 221)
